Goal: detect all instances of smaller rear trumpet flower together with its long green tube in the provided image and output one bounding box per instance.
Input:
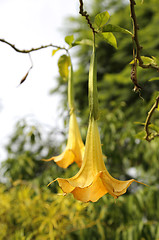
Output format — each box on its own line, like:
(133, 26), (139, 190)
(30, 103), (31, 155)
(43, 61), (85, 168)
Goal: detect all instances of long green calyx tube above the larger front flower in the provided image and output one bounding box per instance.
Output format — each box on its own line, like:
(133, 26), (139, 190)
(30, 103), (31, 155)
(88, 33), (99, 120)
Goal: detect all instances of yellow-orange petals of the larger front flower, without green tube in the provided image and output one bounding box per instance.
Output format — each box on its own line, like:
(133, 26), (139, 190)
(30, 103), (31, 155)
(49, 118), (144, 202)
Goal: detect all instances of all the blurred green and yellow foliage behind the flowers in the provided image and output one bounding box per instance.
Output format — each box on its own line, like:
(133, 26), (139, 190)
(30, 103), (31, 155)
(0, 0), (159, 240)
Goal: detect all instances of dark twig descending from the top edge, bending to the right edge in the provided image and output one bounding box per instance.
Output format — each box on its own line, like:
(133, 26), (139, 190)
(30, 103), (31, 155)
(130, 0), (159, 71)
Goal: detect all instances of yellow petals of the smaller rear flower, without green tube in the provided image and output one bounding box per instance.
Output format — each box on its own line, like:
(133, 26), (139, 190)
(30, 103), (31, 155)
(43, 112), (85, 168)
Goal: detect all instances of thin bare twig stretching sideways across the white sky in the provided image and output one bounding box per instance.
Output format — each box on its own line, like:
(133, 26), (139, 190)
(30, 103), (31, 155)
(0, 39), (68, 53)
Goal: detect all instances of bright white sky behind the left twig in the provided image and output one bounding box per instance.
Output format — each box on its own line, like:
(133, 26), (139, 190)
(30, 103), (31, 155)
(0, 0), (79, 161)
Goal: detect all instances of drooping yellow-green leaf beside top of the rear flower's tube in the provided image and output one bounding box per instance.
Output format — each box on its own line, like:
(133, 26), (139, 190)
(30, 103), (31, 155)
(58, 55), (70, 81)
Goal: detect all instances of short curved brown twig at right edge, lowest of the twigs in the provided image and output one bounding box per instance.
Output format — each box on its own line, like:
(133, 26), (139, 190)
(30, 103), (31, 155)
(144, 96), (159, 142)
